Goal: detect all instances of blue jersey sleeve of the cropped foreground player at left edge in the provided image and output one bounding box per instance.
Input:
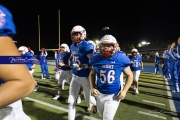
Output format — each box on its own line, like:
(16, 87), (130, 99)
(0, 5), (16, 37)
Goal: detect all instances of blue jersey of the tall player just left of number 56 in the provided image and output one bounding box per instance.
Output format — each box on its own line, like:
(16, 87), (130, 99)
(70, 40), (94, 77)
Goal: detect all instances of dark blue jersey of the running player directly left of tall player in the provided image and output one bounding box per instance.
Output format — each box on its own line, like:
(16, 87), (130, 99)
(56, 52), (71, 70)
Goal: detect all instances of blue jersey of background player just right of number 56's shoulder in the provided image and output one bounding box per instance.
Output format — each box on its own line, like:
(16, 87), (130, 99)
(129, 55), (142, 71)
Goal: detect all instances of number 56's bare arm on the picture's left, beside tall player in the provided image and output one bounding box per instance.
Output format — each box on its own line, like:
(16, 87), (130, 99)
(89, 67), (98, 96)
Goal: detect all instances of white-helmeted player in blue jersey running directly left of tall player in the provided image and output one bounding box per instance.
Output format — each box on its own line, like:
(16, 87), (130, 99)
(53, 43), (72, 100)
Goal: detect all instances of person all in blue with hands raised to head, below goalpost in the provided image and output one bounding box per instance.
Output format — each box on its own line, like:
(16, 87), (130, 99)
(39, 48), (51, 79)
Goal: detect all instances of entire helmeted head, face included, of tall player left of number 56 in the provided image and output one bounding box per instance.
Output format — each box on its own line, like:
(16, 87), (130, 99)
(70, 25), (86, 43)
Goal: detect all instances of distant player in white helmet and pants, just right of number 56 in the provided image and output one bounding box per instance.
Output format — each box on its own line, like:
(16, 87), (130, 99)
(129, 48), (144, 94)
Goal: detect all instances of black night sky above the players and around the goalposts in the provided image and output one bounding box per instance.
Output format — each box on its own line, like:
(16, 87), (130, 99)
(1, 0), (180, 54)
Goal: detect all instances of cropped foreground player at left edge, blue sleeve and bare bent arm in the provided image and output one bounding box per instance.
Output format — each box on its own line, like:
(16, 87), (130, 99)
(0, 5), (35, 120)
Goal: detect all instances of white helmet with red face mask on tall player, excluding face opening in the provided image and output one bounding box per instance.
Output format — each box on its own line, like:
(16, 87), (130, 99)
(71, 25), (86, 43)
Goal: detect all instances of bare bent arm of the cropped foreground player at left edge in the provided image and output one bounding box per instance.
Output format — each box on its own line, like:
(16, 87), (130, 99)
(0, 36), (35, 108)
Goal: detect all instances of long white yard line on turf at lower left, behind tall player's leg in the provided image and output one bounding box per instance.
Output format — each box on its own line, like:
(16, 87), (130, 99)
(25, 97), (100, 120)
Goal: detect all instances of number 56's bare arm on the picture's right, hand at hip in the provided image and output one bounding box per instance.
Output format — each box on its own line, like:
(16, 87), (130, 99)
(118, 66), (133, 100)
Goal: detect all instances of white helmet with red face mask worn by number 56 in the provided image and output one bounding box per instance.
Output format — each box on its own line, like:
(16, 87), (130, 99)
(99, 35), (119, 57)
